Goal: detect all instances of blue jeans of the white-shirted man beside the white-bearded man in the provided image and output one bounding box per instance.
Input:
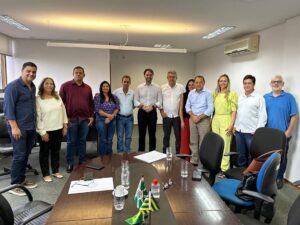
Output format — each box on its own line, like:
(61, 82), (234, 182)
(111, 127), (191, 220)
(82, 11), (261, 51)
(235, 131), (253, 167)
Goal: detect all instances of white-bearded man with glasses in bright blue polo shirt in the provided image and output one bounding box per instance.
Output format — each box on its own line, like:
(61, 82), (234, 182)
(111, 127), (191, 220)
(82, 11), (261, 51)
(264, 75), (298, 189)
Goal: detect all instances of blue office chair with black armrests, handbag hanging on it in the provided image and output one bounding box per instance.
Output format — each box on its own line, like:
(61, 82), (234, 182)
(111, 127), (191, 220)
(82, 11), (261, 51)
(213, 153), (280, 223)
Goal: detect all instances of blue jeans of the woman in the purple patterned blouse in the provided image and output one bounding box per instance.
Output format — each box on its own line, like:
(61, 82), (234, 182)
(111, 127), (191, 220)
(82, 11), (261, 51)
(96, 116), (116, 156)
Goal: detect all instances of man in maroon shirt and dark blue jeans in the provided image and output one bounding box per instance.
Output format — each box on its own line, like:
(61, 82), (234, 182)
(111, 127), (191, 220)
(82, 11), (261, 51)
(59, 66), (94, 173)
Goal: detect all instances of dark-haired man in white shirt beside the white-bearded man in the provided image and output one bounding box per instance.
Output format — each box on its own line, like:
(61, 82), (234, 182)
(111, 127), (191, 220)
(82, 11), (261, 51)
(234, 75), (267, 166)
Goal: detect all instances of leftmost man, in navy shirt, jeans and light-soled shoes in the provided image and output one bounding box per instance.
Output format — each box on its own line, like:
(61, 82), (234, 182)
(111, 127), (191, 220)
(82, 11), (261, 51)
(4, 62), (37, 196)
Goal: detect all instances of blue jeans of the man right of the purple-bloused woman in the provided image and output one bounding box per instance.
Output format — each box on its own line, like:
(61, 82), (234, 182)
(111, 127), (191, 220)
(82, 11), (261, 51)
(117, 115), (133, 152)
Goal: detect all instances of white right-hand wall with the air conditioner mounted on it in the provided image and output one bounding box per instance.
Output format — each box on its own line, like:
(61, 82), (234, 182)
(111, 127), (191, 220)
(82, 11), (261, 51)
(196, 17), (300, 182)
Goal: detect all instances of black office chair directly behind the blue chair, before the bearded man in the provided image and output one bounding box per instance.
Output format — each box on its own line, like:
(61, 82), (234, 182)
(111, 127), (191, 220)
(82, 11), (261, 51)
(225, 127), (286, 180)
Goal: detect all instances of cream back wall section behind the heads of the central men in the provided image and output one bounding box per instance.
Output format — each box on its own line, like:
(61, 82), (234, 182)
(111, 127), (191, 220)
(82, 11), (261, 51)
(111, 51), (195, 123)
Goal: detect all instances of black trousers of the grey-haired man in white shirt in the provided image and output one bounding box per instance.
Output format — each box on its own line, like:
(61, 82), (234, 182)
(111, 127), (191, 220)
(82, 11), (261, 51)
(163, 117), (180, 154)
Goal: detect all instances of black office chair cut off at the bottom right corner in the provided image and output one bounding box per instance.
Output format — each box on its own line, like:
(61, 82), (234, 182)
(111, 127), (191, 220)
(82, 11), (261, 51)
(237, 195), (300, 225)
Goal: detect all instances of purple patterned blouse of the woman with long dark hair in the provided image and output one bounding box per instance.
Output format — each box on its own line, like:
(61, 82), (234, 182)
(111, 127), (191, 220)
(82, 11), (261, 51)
(94, 93), (120, 116)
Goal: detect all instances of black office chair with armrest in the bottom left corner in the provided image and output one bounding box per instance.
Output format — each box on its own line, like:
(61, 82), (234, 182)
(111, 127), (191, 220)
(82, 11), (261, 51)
(0, 184), (53, 225)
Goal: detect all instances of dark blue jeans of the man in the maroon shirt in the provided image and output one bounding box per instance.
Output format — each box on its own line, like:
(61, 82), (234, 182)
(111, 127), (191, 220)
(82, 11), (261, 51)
(67, 119), (89, 165)
